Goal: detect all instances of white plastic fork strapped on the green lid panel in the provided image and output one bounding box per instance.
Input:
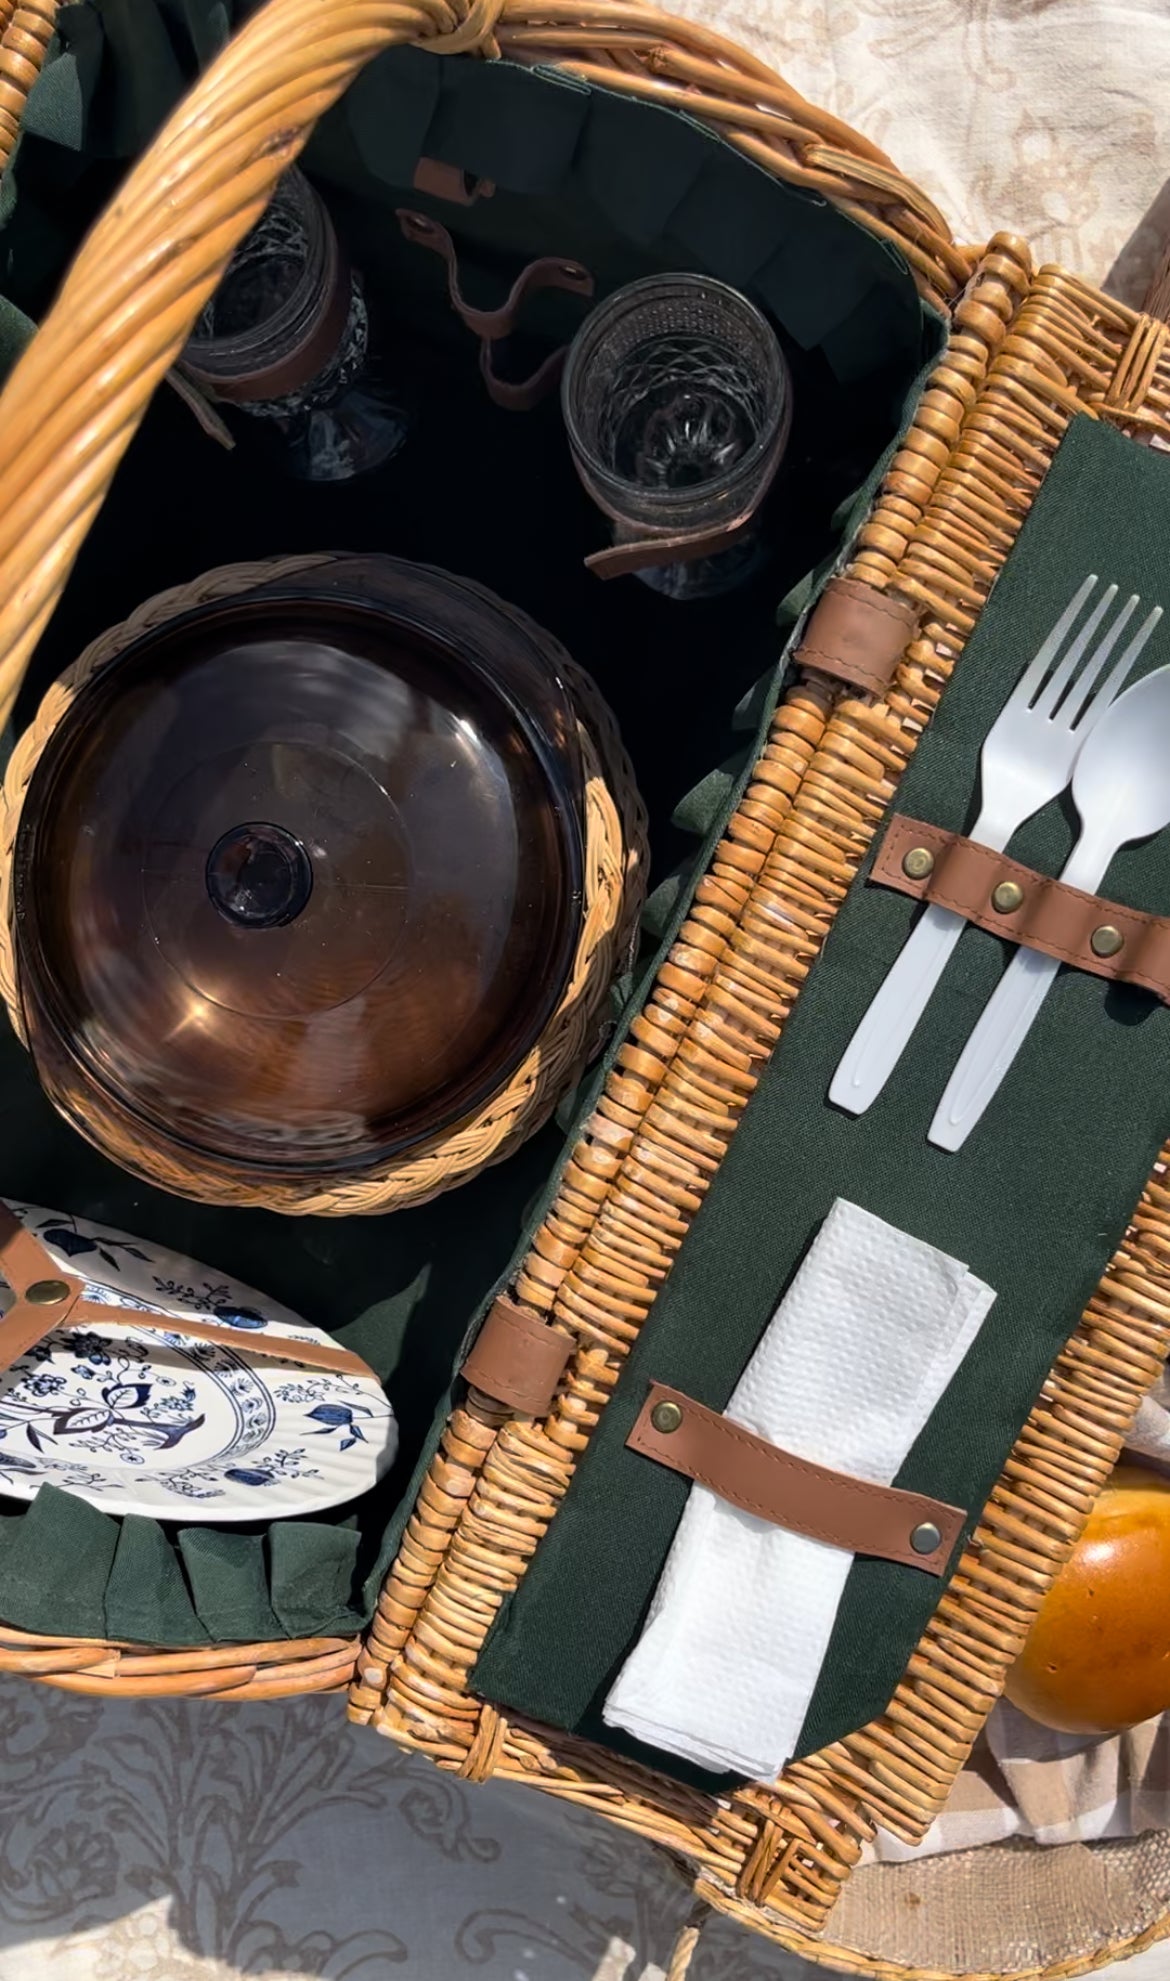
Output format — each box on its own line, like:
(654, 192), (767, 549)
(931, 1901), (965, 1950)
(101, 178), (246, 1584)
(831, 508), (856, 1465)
(829, 574), (1158, 1113)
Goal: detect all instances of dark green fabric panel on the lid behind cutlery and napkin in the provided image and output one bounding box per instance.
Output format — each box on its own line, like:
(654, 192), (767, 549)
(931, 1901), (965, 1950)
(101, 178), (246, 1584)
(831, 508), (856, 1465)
(473, 420), (1170, 1767)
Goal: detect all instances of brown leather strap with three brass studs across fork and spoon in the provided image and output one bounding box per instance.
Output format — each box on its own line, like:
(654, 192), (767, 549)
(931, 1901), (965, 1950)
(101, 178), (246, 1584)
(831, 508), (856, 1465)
(869, 814), (1170, 1004)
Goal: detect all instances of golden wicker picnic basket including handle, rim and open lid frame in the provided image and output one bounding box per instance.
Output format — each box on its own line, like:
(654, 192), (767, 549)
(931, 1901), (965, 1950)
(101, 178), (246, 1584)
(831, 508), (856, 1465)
(0, 0), (1170, 1977)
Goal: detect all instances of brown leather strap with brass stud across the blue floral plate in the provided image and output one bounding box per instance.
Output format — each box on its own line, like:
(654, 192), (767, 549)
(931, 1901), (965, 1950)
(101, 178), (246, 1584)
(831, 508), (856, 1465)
(0, 1202), (372, 1377)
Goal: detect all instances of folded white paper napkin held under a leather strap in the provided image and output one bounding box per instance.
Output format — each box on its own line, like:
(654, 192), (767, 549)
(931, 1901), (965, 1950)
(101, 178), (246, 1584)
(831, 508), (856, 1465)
(604, 1199), (996, 1781)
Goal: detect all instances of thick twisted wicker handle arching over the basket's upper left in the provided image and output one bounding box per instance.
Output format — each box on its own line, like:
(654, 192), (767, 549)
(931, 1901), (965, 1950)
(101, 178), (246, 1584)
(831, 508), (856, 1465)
(0, 0), (501, 727)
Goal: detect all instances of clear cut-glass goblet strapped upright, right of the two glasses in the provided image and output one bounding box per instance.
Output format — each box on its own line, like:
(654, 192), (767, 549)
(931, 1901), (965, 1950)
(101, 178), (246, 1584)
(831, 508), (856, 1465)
(562, 273), (792, 598)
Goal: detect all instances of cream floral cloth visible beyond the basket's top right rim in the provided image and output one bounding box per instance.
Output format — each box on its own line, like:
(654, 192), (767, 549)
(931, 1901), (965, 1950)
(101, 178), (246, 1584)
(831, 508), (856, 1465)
(671, 0), (1170, 301)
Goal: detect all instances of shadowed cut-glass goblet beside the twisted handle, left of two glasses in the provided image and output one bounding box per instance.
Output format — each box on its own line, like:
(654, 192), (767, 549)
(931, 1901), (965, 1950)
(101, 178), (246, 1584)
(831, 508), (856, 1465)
(180, 170), (410, 481)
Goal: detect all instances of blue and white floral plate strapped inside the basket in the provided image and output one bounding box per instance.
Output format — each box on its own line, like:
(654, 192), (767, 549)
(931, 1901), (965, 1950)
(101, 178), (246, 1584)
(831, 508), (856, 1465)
(0, 1202), (398, 1525)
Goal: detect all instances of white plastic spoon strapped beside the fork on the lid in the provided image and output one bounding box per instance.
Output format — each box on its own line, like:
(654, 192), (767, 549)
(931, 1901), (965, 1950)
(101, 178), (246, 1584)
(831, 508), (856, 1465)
(928, 668), (1170, 1149)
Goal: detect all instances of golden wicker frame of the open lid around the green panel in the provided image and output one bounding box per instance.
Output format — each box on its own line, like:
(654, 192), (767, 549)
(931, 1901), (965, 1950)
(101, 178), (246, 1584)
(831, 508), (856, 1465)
(350, 238), (1170, 1961)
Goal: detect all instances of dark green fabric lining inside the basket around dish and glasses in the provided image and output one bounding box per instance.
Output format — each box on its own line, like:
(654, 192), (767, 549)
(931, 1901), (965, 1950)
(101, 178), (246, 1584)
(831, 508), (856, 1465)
(0, 0), (940, 1646)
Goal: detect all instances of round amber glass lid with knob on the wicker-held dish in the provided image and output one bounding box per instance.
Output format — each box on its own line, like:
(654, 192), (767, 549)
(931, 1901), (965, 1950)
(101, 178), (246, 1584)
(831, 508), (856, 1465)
(16, 567), (580, 1175)
